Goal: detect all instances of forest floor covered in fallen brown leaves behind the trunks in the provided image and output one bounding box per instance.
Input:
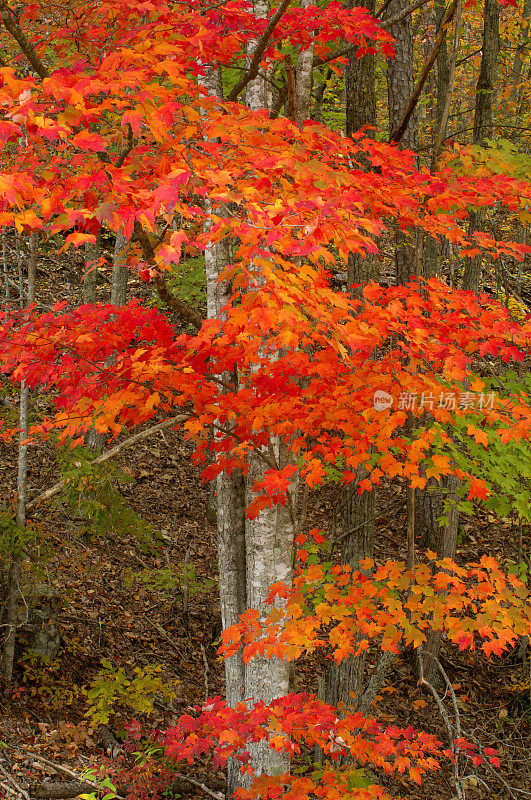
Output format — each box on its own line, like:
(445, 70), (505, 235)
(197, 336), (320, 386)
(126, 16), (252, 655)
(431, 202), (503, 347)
(0, 239), (531, 800)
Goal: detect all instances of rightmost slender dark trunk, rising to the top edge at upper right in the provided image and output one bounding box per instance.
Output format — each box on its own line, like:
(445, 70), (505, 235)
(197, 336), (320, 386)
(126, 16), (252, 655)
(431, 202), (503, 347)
(463, 0), (500, 292)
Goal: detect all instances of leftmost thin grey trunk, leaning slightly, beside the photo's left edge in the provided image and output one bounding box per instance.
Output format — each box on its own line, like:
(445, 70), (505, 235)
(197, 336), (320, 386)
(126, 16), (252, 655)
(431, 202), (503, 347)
(2, 231), (38, 690)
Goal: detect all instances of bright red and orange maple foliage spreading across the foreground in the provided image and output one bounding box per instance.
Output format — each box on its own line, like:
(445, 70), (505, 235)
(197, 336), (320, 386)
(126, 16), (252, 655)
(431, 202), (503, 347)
(0, 0), (531, 798)
